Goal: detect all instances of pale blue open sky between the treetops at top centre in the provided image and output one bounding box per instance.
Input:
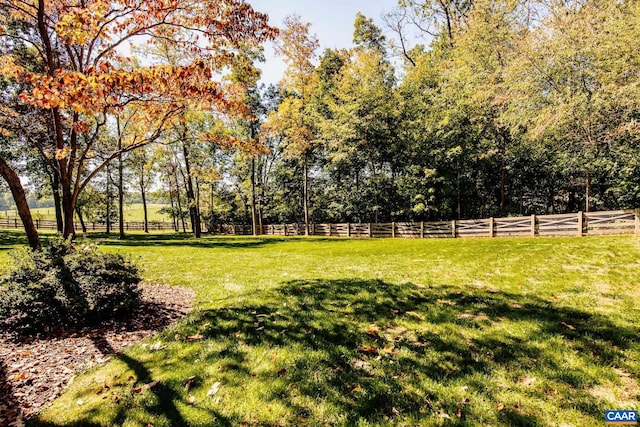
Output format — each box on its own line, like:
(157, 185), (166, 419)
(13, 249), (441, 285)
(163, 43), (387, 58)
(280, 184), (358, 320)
(249, 0), (398, 83)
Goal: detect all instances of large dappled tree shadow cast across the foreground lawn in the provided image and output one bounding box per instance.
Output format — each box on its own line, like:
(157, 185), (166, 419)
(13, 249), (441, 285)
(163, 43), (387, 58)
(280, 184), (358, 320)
(28, 280), (638, 426)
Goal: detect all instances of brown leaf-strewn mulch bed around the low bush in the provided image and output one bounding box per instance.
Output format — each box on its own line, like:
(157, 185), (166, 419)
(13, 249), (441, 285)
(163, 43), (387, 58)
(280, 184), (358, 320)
(0, 284), (194, 427)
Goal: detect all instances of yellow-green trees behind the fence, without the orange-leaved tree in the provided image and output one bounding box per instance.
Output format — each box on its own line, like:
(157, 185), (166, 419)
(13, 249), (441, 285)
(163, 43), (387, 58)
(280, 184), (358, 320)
(7, 0), (640, 237)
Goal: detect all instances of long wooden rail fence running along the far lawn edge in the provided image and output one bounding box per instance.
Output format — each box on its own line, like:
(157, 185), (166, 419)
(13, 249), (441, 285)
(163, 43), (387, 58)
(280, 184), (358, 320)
(0, 210), (640, 239)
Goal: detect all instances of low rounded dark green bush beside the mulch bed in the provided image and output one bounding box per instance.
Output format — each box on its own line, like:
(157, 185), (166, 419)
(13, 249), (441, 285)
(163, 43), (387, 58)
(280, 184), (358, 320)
(0, 237), (141, 333)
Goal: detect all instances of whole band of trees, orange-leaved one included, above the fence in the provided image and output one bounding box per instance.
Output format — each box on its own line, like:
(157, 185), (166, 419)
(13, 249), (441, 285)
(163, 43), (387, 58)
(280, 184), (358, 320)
(0, 0), (640, 247)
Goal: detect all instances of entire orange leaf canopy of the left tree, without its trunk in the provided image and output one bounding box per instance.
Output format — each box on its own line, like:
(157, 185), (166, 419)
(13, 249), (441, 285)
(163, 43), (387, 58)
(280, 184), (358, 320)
(0, 0), (277, 130)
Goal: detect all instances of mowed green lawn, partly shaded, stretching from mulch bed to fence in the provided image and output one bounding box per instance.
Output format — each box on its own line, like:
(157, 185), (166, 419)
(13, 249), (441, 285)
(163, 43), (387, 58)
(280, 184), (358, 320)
(2, 235), (640, 427)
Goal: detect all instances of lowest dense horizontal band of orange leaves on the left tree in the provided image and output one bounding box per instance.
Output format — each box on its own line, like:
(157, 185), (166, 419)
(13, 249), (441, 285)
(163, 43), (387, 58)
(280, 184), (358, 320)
(11, 62), (249, 115)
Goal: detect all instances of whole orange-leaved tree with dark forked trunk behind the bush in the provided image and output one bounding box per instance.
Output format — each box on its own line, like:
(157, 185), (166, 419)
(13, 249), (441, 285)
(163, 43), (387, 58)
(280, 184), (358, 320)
(0, 0), (275, 247)
